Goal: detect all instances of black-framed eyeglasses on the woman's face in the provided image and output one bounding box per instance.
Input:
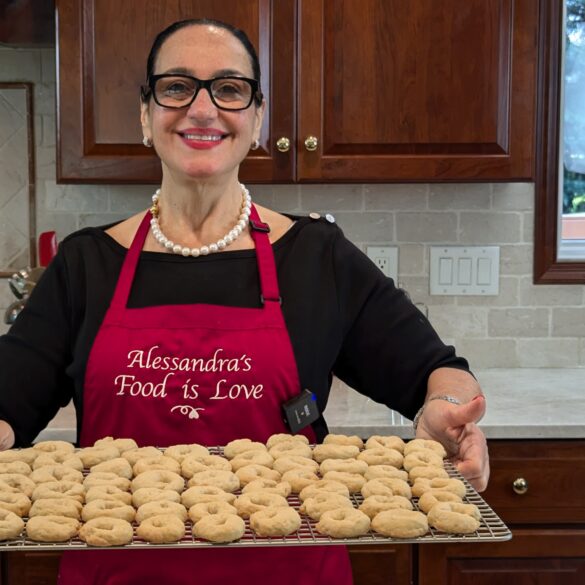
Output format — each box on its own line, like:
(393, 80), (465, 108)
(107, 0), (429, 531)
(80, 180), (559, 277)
(141, 73), (262, 111)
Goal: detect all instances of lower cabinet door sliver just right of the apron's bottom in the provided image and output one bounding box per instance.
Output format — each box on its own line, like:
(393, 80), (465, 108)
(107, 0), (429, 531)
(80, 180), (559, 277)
(348, 544), (413, 585)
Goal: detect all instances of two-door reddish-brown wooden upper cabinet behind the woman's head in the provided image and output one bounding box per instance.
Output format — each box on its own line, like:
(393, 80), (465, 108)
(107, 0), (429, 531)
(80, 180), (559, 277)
(57, 0), (550, 183)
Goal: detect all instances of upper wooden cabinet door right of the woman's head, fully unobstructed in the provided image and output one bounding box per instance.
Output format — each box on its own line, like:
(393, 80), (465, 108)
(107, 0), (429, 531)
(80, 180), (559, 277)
(297, 0), (538, 182)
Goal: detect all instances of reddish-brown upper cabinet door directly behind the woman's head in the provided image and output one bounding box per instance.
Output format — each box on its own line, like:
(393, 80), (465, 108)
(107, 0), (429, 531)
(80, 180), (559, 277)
(56, 0), (296, 183)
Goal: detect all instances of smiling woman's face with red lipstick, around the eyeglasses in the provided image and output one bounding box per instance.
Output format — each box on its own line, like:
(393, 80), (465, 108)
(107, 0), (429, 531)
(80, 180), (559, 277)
(141, 25), (264, 180)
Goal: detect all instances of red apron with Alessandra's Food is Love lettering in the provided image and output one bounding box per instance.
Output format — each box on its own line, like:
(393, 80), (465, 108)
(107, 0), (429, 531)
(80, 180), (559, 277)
(59, 207), (352, 585)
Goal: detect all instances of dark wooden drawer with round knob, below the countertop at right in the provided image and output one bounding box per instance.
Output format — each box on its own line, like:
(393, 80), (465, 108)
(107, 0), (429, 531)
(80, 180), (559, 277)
(482, 440), (585, 524)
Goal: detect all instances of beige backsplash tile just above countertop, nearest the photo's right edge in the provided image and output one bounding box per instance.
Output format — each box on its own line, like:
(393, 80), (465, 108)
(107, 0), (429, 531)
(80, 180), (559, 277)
(518, 338), (585, 364)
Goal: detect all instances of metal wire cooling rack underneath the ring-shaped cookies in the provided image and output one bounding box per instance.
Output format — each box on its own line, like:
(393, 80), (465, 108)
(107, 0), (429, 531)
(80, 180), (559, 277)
(0, 447), (512, 552)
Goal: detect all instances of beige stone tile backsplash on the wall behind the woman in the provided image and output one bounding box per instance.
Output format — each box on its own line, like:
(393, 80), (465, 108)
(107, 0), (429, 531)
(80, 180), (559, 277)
(0, 48), (585, 369)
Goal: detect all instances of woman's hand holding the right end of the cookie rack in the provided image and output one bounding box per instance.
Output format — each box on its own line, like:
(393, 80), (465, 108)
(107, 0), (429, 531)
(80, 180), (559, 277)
(416, 396), (490, 492)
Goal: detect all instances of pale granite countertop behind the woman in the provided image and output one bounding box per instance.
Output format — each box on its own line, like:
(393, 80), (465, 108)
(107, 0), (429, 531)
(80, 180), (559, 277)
(38, 368), (585, 442)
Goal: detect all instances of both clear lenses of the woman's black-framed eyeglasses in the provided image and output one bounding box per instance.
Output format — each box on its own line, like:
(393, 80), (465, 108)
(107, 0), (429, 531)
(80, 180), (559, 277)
(154, 76), (252, 110)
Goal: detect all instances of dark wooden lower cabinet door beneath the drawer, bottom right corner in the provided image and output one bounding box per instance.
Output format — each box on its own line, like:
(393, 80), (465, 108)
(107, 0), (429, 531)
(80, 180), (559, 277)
(418, 528), (585, 585)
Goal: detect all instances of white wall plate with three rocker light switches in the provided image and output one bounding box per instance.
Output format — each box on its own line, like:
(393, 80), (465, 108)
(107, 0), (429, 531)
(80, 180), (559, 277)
(430, 246), (500, 295)
